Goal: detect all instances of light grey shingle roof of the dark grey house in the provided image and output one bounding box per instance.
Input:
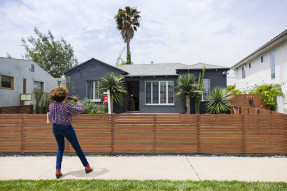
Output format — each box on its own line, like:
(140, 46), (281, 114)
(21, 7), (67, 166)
(119, 63), (230, 76)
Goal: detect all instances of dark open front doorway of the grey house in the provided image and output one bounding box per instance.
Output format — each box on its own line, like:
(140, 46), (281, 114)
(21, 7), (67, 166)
(126, 81), (139, 111)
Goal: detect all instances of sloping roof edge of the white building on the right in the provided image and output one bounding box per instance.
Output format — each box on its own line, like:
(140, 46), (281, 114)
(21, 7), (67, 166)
(231, 29), (287, 69)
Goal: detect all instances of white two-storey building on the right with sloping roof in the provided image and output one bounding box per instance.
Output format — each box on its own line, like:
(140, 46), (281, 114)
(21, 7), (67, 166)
(232, 30), (287, 113)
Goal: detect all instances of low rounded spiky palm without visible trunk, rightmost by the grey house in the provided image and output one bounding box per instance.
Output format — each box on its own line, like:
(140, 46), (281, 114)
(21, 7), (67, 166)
(206, 87), (232, 114)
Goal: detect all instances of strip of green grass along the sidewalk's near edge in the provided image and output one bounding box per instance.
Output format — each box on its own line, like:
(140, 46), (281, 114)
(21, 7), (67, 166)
(0, 180), (287, 191)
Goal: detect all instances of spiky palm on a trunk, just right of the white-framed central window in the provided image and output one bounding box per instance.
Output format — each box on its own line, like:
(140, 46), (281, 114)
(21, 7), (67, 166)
(176, 73), (198, 114)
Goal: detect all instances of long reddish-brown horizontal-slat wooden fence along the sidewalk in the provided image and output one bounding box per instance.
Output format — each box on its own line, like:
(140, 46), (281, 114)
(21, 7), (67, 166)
(0, 114), (287, 154)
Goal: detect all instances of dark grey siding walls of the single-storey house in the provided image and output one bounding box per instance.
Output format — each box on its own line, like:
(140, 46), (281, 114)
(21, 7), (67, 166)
(65, 59), (230, 114)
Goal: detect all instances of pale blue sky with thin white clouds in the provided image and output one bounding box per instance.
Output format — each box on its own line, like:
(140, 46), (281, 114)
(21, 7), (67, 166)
(0, 0), (287, 79)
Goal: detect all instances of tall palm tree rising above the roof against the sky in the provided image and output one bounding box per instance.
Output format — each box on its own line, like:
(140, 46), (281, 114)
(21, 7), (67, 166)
(114, 6), (140, 64)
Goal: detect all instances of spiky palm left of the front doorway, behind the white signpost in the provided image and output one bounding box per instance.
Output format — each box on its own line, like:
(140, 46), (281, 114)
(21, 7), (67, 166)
(98, 72), (127, 112)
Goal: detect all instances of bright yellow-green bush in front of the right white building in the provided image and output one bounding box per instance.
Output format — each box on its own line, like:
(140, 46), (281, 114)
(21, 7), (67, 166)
(249, 84), (285, 111)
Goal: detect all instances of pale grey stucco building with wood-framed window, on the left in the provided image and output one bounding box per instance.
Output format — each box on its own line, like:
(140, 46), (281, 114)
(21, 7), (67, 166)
(0, 57), (58, 107)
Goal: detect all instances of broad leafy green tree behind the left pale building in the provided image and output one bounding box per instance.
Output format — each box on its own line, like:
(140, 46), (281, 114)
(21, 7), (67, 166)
(22, 27), (78, 78)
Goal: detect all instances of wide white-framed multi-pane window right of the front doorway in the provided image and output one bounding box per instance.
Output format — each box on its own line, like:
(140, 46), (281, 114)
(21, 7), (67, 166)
(145, 81), (174, 105)
